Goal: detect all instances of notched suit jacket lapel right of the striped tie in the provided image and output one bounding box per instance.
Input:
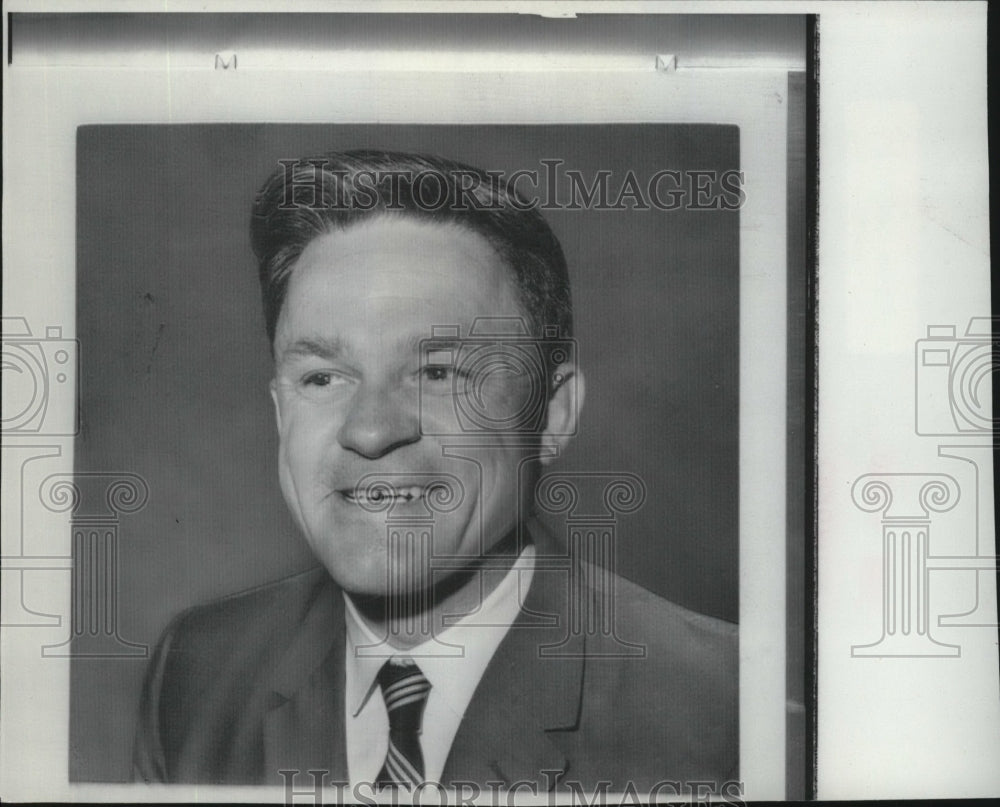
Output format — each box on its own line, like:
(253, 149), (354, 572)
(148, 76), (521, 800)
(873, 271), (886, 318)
(443, 556), (584, 792)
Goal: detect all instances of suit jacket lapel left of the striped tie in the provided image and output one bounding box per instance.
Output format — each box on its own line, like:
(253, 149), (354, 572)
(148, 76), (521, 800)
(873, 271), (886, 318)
(264, 580), (347, 784)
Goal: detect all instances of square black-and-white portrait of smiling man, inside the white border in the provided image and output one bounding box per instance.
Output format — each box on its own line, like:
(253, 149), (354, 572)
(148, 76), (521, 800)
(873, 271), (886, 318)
(78, 125), (743, 792)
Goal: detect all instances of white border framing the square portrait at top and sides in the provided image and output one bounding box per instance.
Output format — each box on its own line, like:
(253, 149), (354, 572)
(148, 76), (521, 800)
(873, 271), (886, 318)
(0, 34), (787, 800)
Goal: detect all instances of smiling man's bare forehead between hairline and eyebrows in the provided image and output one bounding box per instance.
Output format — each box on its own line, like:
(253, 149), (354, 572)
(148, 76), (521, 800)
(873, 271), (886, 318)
(275, 217), (527, 355)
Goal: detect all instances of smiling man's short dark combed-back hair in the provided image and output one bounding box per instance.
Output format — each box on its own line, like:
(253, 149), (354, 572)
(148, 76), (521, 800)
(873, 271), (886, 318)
(250, 150), (573, 347)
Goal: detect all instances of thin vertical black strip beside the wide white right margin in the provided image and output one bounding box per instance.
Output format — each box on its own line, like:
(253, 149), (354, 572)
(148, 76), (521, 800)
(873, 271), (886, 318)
(802, 14), (820, 800)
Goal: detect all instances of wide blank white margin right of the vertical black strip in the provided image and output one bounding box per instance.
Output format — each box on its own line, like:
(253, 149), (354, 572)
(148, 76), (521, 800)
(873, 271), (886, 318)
(818, 3), (1000, 799)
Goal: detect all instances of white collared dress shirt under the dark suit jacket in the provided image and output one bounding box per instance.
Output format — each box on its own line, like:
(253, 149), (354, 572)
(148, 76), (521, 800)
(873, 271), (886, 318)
(344, 546), (535, 785)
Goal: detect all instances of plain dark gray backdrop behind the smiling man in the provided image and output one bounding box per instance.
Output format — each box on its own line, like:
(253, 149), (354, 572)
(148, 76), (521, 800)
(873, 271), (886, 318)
(70, 125), (744, 781)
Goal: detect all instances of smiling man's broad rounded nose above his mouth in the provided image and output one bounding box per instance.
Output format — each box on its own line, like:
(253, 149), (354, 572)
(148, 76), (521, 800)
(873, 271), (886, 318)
(337, 382), (420, 459)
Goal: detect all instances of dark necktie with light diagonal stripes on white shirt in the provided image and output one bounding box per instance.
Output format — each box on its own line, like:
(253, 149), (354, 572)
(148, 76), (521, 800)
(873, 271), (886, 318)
(376, 659), (431, 788)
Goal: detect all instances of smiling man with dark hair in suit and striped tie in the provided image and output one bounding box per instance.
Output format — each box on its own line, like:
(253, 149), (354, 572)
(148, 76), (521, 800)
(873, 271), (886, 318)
(135, 151), (738, 794)
